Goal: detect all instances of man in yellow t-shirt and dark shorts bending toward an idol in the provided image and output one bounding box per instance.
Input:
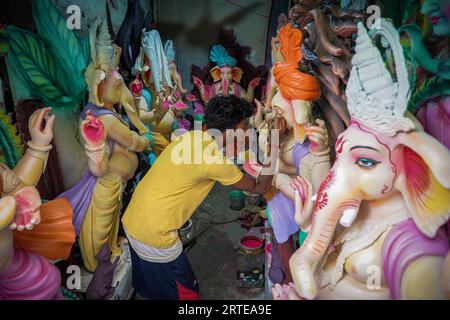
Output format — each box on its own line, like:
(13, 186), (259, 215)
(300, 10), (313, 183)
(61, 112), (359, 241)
(122, 95), (273, 300)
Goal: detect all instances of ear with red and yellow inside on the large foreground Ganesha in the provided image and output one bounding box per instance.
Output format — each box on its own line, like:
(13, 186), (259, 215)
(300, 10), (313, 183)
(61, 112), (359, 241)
(396, 131), (450, 238)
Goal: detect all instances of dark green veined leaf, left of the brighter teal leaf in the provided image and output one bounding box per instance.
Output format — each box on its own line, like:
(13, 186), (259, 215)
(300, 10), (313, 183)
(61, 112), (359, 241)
(7, 26), (79, 107)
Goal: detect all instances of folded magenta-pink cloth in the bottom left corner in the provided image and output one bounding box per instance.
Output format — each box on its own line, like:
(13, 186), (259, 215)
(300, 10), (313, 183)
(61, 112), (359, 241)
(0, 247), (63, 300)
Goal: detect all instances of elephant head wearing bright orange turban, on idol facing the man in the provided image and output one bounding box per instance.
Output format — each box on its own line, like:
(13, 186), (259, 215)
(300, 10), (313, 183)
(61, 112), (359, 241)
(271, 24), (320, 143)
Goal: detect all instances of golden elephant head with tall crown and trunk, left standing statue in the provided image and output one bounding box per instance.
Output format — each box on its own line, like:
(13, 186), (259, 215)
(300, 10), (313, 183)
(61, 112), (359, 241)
(85, 19), (148, 134)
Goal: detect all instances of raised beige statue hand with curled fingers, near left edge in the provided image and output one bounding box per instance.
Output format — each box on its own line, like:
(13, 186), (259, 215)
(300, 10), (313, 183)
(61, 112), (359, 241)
(28, 107), (56, 147)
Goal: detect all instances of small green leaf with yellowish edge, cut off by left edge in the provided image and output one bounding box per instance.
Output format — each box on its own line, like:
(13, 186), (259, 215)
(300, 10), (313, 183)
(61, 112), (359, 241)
(0, 110), (24, 168)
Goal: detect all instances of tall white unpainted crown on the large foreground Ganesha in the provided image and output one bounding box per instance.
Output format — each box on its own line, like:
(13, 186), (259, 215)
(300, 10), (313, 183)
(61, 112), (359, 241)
(346, 19), (414, 136)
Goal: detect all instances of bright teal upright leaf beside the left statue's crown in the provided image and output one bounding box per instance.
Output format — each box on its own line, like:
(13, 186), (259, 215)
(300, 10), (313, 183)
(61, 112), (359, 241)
(32, 0), (87, 96)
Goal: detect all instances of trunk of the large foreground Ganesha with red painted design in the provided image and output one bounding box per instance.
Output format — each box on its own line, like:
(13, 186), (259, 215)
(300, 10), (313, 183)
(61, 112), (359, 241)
(289, 168), (362, 299)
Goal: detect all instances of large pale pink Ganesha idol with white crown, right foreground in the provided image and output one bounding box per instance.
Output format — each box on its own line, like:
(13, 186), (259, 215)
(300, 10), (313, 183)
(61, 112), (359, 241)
(273, 20), (450, 299)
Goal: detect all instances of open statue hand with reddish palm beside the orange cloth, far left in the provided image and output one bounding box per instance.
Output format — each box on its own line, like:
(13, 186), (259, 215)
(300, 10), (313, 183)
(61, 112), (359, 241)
(10, 187), (41, 231)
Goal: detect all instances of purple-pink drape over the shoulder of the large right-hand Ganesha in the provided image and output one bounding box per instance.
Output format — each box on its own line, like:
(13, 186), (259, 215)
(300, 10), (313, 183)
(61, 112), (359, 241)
(382, 219), (449, 300)
